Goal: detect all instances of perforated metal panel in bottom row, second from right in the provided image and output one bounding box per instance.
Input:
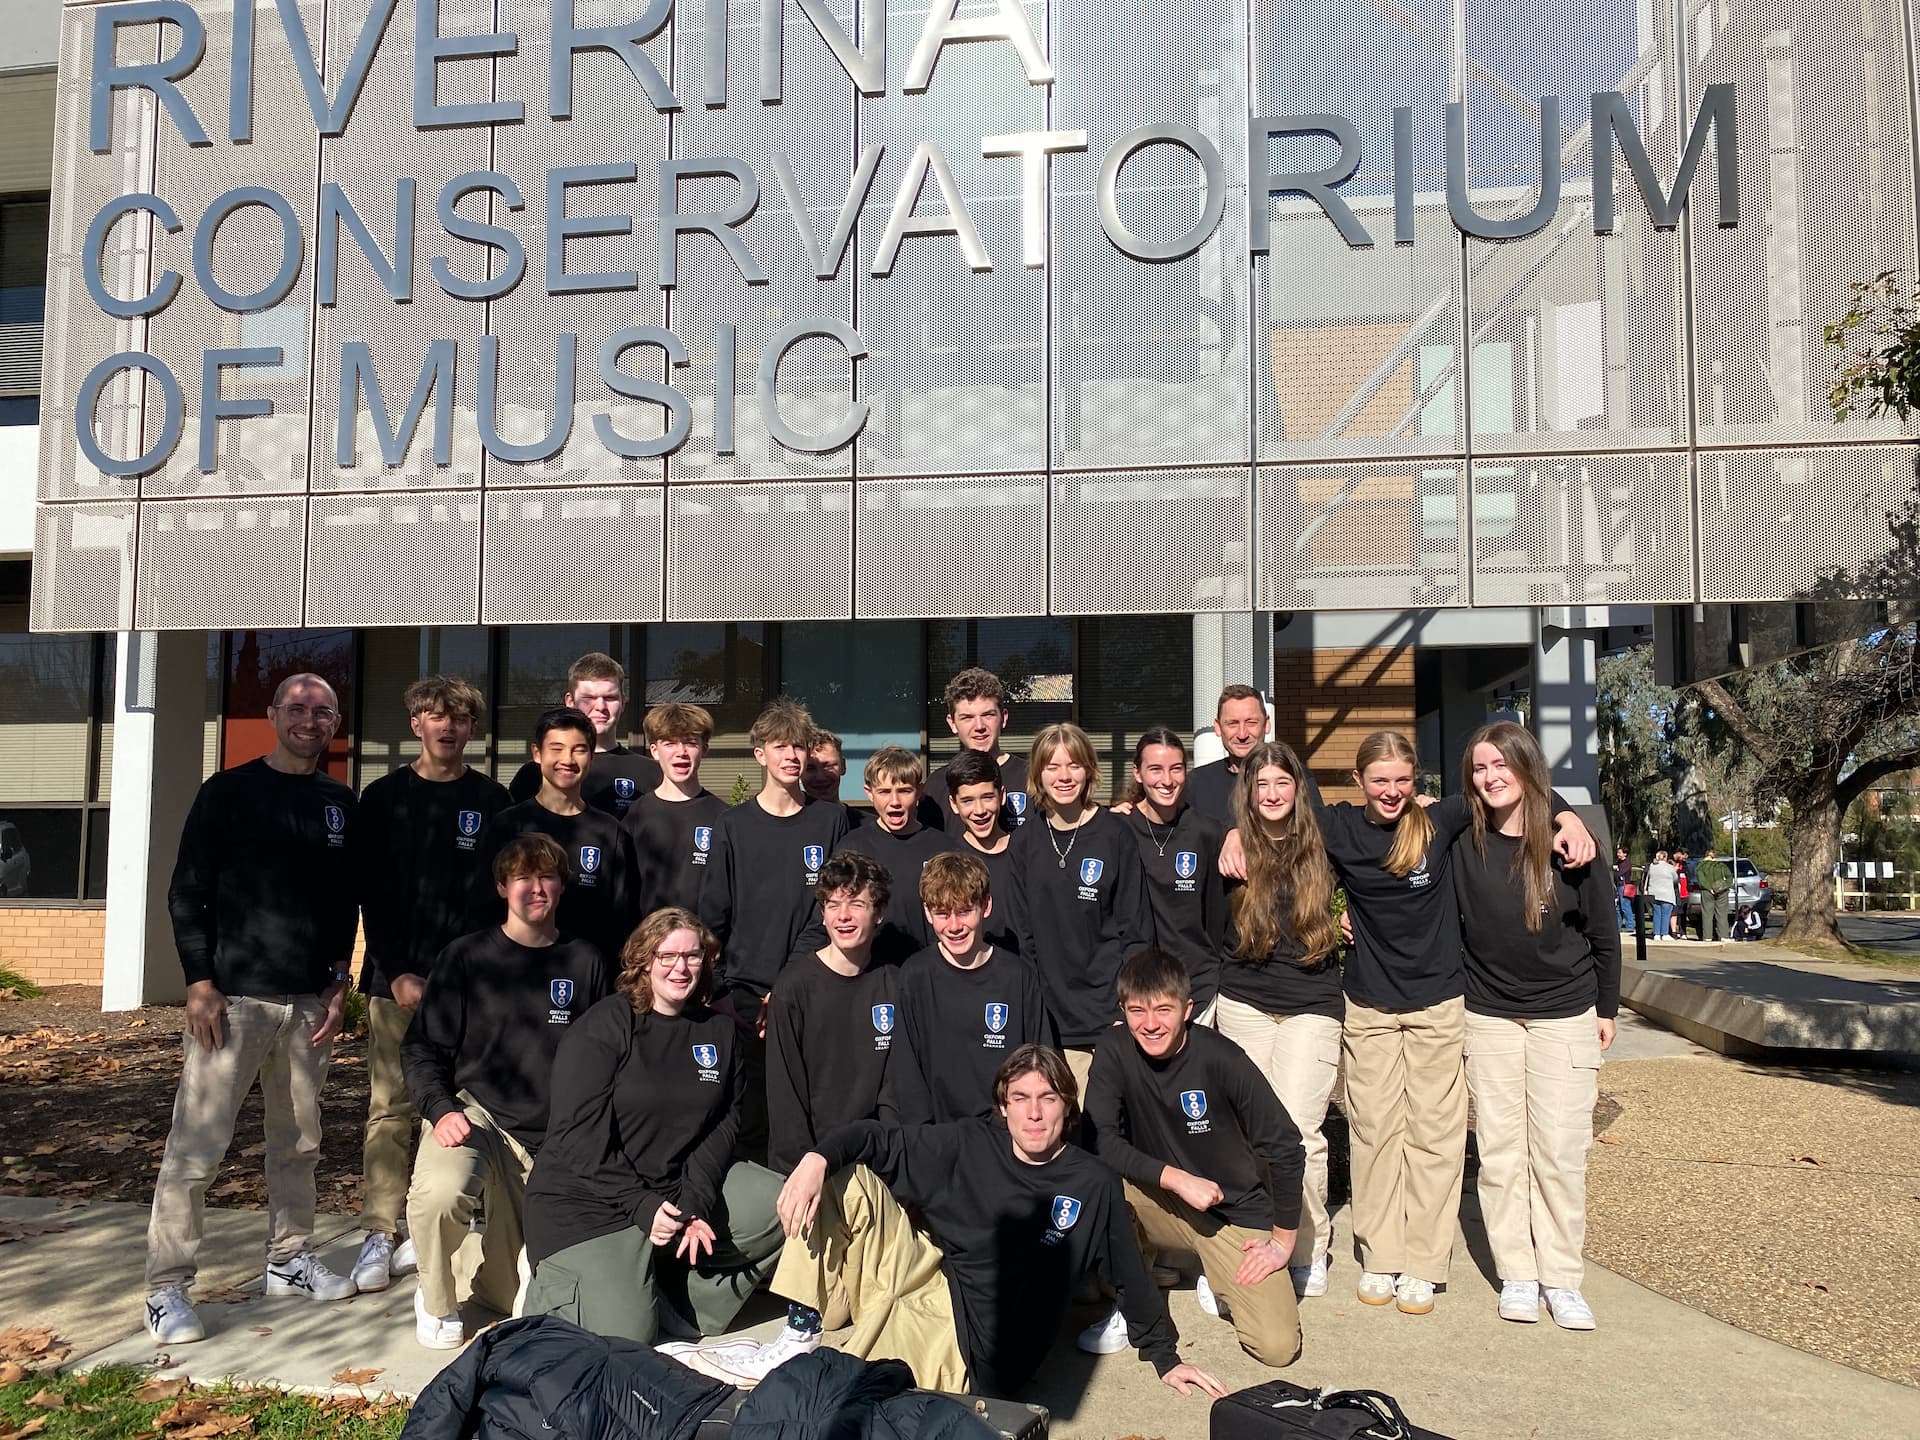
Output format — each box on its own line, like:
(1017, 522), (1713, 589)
(1473, 455), (1693, 605)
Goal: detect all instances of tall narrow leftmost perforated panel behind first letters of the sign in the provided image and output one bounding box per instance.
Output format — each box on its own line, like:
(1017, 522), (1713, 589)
(38, 8), (159, 503)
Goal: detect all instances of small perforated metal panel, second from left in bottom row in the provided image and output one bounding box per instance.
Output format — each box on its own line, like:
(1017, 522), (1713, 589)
(132, 495), (307, 630)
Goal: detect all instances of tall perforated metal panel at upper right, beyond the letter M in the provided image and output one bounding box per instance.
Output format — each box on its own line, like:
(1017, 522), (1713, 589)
(1686, 0), (1920, 445)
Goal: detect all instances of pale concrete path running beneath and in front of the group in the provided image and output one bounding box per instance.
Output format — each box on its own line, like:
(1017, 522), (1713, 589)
(11, 1200), (1920, 1440)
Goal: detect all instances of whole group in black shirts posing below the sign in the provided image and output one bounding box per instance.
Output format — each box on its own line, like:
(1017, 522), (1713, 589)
(148, 655), (1619, 1396)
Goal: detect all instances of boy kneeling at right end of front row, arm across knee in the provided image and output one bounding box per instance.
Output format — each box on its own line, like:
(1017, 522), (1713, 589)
(1079, 948), (1306, 1367)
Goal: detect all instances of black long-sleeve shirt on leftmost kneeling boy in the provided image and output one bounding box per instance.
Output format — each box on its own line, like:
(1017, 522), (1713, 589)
(399, 927), (609, 1152)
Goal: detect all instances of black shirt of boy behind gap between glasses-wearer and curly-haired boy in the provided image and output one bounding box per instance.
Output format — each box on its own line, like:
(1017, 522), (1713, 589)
(701, 799), (847, 995)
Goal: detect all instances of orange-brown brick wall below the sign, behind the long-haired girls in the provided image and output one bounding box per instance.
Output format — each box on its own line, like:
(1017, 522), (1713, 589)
(1273, 645), (1413, 803)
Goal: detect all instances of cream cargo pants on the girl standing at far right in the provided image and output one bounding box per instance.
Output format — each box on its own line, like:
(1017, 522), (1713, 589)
(1467, 1010), (1599, 1290)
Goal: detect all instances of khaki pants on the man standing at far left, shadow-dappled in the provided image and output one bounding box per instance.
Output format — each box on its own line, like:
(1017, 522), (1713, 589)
(146, 995), (334, 1294)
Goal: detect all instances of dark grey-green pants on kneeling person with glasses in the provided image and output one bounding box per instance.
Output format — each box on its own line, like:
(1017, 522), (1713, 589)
(526, 1162), (785, 1344)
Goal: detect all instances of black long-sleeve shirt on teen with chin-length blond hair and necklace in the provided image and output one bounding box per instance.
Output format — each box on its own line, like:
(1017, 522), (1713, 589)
(1008, 808), (1154, 1044)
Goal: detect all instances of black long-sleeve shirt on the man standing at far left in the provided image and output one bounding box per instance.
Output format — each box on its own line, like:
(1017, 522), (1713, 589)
(167, 760), (359, 995)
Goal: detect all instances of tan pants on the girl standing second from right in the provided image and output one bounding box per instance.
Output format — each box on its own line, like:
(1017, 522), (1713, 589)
(1340, 998), (1467, 1284)
